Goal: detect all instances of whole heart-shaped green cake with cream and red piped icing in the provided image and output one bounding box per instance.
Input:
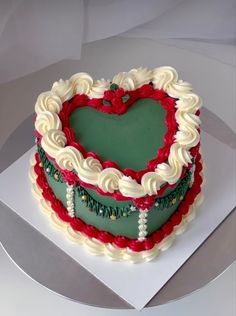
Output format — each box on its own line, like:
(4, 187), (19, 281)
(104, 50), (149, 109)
(30, 67), (202, 261)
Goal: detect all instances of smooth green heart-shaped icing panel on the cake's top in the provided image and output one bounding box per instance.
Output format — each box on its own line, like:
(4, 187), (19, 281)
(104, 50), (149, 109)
(70, 98), (166, 170)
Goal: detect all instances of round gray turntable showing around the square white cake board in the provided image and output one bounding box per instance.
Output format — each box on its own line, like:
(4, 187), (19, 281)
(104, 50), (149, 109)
(0, 109), (236, 308)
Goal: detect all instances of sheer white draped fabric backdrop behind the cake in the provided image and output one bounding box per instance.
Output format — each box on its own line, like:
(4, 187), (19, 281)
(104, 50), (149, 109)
(0, 0), (236, 83)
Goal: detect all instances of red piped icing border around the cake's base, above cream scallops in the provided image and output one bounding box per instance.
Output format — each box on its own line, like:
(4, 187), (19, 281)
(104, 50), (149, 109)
(34, 153), (202, 252)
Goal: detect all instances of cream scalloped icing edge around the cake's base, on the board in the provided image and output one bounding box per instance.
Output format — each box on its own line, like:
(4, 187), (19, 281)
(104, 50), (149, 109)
(29, 154), (204, 263)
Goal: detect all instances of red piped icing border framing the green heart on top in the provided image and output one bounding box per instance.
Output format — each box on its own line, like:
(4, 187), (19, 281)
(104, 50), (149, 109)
(36, 84), (183, 183)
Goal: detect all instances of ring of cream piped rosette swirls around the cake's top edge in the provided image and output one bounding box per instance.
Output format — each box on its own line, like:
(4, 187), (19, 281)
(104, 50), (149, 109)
(35, 67), (201, 198)
